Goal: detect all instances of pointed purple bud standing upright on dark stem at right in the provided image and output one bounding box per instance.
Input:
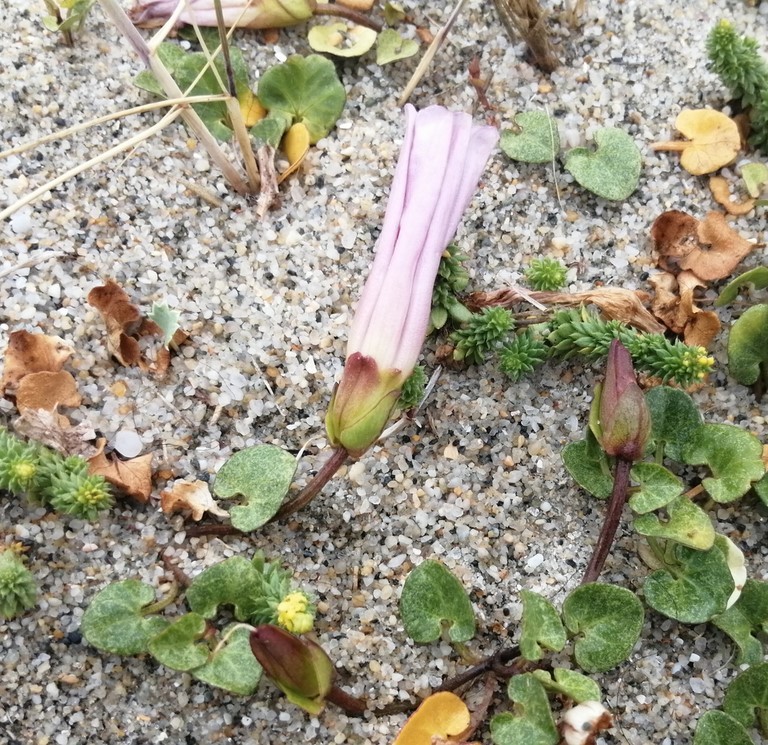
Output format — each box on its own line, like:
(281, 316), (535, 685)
(595, 339), (651, 461)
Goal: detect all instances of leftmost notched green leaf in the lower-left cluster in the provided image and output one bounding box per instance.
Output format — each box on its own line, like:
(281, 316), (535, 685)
(80, 579), (168, 655)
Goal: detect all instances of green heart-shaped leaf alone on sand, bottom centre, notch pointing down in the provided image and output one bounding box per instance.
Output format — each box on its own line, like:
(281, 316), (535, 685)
(400, 559), (475, 644)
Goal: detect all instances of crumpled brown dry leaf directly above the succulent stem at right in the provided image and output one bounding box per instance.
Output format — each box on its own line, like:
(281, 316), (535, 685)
(649, 272), (720, 347)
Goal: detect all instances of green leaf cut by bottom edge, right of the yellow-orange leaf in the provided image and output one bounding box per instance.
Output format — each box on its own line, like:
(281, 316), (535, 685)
(491, 673), (560, 745)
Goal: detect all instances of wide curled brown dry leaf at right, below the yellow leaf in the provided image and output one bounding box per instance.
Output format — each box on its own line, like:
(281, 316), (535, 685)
(651, 210), (758, 282)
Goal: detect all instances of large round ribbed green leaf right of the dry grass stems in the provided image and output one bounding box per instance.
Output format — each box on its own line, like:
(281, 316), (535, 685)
(258, 54), (347, 144)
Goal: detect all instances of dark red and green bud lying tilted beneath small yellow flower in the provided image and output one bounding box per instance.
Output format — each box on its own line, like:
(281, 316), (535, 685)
(250, 624), (335, 716)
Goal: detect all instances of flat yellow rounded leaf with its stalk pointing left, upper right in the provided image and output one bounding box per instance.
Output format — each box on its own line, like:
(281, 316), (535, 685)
(651, 109), (741, 176)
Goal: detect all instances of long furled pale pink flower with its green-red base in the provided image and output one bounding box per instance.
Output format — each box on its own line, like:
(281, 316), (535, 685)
(325, 105), (498, 457)
